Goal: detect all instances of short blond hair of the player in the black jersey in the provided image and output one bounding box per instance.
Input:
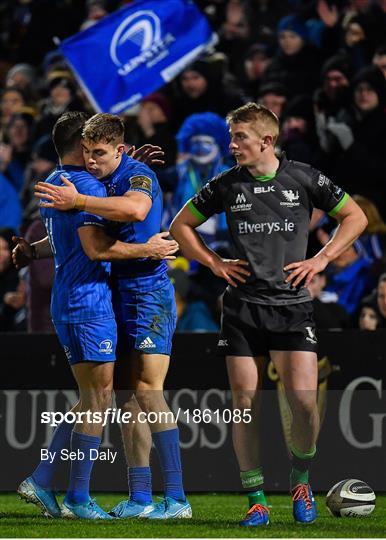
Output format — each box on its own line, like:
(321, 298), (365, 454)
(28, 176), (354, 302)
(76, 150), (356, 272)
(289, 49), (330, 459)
(226, 102), (279, 144)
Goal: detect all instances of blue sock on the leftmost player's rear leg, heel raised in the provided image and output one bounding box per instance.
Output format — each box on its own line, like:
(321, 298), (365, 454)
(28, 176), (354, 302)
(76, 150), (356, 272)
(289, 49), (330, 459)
(31, 422), (74, 489)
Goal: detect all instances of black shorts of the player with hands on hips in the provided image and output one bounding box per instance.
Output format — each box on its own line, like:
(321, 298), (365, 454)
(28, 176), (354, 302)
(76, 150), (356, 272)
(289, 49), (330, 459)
(217, 291), (317, 356)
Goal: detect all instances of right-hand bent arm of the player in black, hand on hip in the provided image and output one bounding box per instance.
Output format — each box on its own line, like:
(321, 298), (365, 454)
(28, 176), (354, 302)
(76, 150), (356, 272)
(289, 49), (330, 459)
(284, 195), (367, 287)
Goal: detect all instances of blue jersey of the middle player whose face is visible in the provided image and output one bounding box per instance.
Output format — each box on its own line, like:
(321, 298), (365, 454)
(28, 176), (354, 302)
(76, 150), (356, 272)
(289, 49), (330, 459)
(103, 154), (168, 292)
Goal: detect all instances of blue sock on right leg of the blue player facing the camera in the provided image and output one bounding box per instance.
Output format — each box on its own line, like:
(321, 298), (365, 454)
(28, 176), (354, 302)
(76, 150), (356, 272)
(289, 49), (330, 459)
(152, 428), (185, 501)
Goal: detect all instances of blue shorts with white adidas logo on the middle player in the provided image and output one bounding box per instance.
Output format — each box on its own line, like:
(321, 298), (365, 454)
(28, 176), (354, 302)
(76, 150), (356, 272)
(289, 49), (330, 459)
(113, 282), (177, 356)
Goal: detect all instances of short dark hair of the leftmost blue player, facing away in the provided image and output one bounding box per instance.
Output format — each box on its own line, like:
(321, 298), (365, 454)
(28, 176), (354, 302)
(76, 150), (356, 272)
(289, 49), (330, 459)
(52, 111), (88, 158)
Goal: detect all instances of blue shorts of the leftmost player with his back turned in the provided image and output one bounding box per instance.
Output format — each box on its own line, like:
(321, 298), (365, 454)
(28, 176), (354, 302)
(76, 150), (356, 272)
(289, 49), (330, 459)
(54, 319), (118, 365)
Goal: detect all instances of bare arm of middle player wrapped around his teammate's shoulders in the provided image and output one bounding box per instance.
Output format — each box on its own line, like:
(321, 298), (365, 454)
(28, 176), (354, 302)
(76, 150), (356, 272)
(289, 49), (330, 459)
(35, 176), (152, 222)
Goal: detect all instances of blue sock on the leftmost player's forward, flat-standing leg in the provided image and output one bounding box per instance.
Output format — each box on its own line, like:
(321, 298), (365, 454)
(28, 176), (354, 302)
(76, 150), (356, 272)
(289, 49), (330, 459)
(65, 431), (101, 504)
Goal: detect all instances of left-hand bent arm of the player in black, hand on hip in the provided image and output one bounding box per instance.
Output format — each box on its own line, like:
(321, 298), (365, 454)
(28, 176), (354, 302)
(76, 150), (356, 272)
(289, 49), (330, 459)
(170, 201), (250, 287)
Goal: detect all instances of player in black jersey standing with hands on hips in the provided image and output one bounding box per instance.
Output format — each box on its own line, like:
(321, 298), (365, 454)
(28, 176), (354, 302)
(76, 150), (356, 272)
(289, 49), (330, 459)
(170, 103), (367, 526)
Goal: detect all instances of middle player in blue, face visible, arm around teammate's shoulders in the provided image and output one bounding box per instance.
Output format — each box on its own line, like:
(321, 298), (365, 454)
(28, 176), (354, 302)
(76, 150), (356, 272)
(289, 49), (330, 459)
(37, 114), (191, 519)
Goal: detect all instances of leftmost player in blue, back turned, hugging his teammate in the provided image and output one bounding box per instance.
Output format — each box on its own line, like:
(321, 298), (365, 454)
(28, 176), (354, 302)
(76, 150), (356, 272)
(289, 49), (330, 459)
(14, 113), (178, 519)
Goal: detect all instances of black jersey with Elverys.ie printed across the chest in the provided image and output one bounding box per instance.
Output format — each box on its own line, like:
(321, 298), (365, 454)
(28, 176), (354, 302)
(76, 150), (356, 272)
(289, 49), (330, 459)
(188, 155), (348, 305)
